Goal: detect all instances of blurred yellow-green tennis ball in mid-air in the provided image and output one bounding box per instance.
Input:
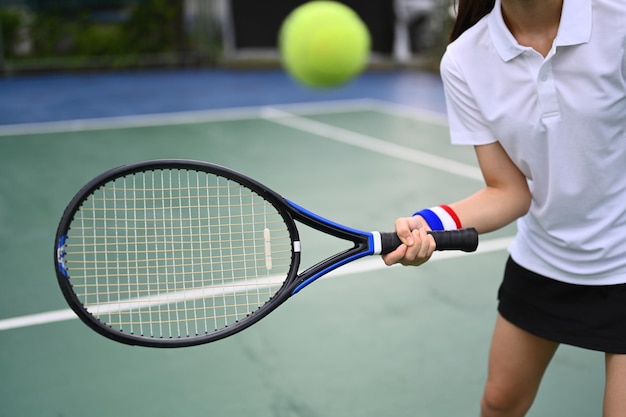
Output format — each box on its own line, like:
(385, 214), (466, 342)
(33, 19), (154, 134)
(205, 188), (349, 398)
(278, 0), (370, 88)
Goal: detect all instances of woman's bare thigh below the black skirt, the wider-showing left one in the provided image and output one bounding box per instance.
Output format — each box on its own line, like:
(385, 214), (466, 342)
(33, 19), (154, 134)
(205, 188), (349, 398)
(481, 315), (558, 417)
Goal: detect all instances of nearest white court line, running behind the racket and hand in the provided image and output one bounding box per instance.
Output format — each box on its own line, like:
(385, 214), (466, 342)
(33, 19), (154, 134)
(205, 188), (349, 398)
(0, 238), (512, 331)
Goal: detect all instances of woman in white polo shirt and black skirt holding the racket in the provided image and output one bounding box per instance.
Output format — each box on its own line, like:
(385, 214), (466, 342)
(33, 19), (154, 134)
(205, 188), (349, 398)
(384, 0), (626, 417)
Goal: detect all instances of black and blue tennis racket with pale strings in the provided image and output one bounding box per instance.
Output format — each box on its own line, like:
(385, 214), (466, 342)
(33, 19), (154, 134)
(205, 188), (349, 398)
(54, 160), (478, 347)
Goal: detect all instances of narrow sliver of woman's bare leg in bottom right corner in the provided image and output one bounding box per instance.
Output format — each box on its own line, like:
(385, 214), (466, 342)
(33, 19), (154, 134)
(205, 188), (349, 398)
(602, 353), (626, 417)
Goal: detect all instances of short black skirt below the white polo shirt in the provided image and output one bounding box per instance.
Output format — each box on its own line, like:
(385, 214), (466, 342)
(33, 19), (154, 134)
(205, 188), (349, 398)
(498, 258), (626, 354)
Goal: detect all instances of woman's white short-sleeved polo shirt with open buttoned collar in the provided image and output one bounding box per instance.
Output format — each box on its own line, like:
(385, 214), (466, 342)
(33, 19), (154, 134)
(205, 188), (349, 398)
(441, 0), (626, 285)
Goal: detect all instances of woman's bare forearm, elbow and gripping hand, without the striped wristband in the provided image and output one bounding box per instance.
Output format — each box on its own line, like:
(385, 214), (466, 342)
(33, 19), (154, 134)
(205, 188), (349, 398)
(383, 142), (531, 265)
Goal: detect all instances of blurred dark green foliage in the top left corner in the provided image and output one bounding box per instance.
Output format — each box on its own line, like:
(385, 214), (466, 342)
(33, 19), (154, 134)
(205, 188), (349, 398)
(0, 0), (214, 73)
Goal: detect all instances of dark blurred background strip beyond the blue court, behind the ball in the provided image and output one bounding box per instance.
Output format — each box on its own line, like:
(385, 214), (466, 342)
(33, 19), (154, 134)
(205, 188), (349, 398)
(0, 0), (453, 75)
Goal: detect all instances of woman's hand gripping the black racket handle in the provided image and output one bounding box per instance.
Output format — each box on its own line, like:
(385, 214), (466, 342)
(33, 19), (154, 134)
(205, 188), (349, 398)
(383, 216), (436, 266)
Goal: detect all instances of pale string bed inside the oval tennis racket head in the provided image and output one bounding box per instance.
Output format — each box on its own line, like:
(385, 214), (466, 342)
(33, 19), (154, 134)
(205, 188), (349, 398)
(65, 169), (293, 338)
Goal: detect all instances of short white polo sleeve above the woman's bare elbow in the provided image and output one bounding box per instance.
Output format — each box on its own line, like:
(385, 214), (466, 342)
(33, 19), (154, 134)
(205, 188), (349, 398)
(440, 48), (497, 145)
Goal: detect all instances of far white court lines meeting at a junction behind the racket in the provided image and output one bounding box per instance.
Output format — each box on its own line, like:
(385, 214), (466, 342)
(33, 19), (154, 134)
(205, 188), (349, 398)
(0, 99), (483, 182)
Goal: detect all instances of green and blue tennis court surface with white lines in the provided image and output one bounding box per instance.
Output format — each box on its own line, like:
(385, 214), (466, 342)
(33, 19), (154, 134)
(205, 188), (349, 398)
(0, 70), (604, 417)
